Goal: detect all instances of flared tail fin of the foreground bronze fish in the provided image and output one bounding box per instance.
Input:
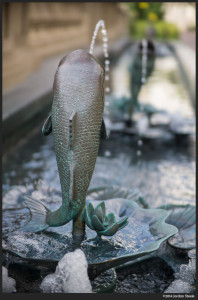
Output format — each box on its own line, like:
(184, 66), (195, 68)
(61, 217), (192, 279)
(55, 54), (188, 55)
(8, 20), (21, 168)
(21, 196), (51, 232)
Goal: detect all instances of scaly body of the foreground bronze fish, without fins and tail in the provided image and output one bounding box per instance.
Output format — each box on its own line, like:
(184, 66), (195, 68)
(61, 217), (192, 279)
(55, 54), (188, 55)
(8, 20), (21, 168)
(52, 51), (104, 224)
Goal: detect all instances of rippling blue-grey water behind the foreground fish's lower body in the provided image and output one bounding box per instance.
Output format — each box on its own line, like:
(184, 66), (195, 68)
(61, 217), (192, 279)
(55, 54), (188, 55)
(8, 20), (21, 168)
(3, 123), (195, 207)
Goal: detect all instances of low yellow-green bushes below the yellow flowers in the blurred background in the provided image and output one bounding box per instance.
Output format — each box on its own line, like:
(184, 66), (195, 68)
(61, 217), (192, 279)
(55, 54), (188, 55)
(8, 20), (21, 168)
(130, 20), (179, 39)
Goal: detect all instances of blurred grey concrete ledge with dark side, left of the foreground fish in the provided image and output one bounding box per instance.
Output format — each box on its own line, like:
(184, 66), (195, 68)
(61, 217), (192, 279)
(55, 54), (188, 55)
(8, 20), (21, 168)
(3, 55), (62, 151)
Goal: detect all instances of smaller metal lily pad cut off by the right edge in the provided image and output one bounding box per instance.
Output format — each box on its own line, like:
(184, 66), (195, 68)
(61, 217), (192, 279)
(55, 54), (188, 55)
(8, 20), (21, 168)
(160, 204), (196, 250)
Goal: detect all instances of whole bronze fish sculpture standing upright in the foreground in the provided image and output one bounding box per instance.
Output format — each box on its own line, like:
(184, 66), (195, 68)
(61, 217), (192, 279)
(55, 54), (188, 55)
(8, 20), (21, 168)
(25, 50), (106, 236)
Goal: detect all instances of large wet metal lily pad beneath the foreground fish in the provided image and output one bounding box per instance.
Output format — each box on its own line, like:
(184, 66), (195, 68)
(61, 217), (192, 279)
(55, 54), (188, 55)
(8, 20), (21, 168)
(3, 198), (177, 278)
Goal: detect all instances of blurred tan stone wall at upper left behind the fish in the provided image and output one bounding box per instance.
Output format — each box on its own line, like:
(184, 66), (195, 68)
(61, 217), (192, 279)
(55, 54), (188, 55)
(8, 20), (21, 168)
(2, 2), (127, 91)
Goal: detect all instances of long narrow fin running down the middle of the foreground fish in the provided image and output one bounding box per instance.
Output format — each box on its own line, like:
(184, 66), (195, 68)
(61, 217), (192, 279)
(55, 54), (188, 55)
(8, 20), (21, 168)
(69, 111), (77, 206)
